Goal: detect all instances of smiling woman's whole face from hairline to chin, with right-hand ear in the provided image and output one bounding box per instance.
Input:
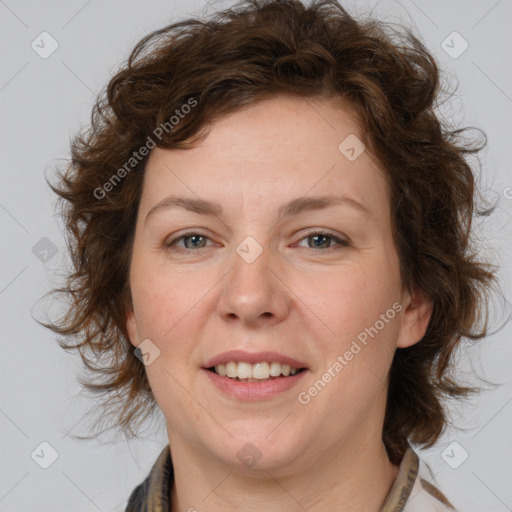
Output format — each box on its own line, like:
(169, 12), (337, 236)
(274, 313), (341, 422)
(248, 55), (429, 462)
(127, 96), (429, 471)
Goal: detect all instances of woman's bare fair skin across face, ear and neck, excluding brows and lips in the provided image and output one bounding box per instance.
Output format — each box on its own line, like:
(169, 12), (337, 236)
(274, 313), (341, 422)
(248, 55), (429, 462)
(127, 96), (431, 512)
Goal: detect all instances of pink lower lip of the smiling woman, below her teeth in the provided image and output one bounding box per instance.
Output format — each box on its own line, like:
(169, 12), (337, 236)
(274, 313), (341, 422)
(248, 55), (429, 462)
(203, 369), (307, 400)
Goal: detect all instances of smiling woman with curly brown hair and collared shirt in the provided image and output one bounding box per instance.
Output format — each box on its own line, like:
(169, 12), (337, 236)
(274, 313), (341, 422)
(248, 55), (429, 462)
(48, 0), (493, 512)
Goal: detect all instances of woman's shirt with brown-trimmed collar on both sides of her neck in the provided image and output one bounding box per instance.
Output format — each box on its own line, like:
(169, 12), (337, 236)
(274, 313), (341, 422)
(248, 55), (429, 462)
(125, 445), (455, 512)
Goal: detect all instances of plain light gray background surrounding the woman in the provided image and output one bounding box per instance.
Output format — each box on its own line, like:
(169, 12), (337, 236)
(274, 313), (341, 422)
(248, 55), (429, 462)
(0, 0), (512, 512)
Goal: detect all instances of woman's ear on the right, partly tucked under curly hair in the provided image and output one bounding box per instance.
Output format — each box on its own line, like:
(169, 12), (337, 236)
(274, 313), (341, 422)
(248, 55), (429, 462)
(396, 290), (433, 348)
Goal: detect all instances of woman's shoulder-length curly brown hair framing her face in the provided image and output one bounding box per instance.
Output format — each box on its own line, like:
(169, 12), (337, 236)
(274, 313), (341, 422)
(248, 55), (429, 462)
(47, 0), (494, 463)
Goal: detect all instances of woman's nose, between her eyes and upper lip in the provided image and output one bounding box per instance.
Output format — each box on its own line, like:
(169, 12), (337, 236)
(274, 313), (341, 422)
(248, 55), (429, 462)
(218, 241), (291, 327)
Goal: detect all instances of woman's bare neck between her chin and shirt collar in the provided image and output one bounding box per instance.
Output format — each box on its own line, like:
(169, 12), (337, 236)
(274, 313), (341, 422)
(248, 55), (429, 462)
(170, 439), (398, 512)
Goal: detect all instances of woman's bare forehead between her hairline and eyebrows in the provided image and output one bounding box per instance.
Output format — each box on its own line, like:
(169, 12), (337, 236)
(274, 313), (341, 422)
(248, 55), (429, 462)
(141, 96), (389, 220)
